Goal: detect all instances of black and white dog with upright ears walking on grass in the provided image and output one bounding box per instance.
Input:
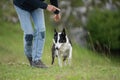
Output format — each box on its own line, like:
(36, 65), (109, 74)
(51, 29), (72, 67)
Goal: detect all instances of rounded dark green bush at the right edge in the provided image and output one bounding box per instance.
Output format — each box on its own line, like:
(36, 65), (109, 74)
(87, 10), (120, 50)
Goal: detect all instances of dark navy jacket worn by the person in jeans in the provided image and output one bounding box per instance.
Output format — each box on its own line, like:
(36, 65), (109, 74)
(13, 0), (59, 14)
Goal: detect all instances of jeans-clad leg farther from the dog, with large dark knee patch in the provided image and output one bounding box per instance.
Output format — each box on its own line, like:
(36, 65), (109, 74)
(15, 6), (33, 64)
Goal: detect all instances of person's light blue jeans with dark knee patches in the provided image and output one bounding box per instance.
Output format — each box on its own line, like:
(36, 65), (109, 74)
(15, 6), (45, 61)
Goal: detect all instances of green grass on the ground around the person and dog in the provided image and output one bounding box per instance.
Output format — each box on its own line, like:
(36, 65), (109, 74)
(0, 22), (120, 80)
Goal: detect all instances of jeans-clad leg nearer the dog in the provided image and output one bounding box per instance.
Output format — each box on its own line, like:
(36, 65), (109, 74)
(31, 8), (46, 68)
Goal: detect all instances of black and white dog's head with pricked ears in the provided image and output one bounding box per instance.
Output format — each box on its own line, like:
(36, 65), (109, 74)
(53, 29), (67, 49)
